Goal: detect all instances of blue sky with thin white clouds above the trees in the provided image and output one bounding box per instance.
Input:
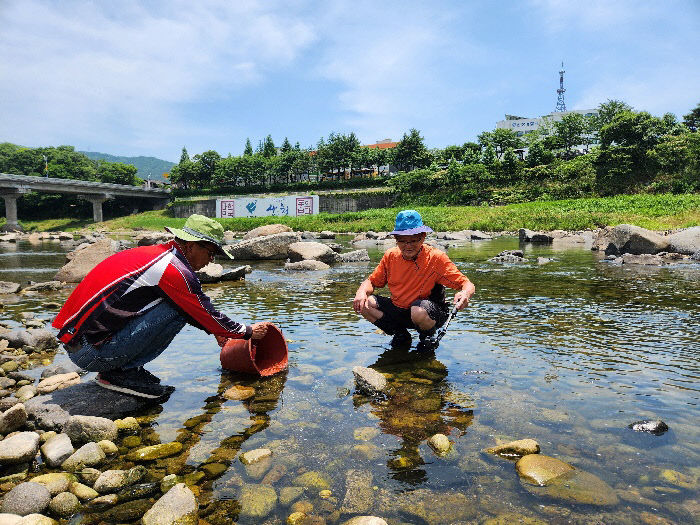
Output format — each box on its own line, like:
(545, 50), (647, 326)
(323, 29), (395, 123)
(0, 0), (700, 162)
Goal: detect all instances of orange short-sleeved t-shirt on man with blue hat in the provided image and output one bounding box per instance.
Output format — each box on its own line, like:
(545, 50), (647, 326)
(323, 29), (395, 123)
(369, 244), (469, 308)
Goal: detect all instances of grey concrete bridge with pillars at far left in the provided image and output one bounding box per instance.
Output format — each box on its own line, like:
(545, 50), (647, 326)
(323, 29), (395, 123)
(0, 173), (170, 230)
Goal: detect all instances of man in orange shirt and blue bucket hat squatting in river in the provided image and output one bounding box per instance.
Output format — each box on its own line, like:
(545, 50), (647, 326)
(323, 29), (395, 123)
(353, 210), (474, 348)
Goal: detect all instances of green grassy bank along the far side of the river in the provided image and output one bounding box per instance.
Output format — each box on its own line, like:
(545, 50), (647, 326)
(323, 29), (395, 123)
(13, 194), (700, 232)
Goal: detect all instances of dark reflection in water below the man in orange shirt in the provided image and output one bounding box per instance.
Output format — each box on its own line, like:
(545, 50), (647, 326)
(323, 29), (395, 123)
(354, 348), (474, 484)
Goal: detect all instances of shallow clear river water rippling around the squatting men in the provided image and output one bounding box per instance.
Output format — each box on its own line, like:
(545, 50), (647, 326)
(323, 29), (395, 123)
(0, 237), (700, 524)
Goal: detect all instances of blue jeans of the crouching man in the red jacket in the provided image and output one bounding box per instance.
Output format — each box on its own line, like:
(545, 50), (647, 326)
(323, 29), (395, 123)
(68, 300), (186, 372)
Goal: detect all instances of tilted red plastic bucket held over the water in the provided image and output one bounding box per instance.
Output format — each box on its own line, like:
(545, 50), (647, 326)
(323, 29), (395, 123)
(219, 324), (289, 376)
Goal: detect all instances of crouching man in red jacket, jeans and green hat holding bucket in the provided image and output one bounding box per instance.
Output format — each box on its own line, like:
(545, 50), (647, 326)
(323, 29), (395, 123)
(53, 215), (268, 398)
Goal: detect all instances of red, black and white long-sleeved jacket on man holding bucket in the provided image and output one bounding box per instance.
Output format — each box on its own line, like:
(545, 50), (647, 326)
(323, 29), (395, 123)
(52, 241), (252, 346)
